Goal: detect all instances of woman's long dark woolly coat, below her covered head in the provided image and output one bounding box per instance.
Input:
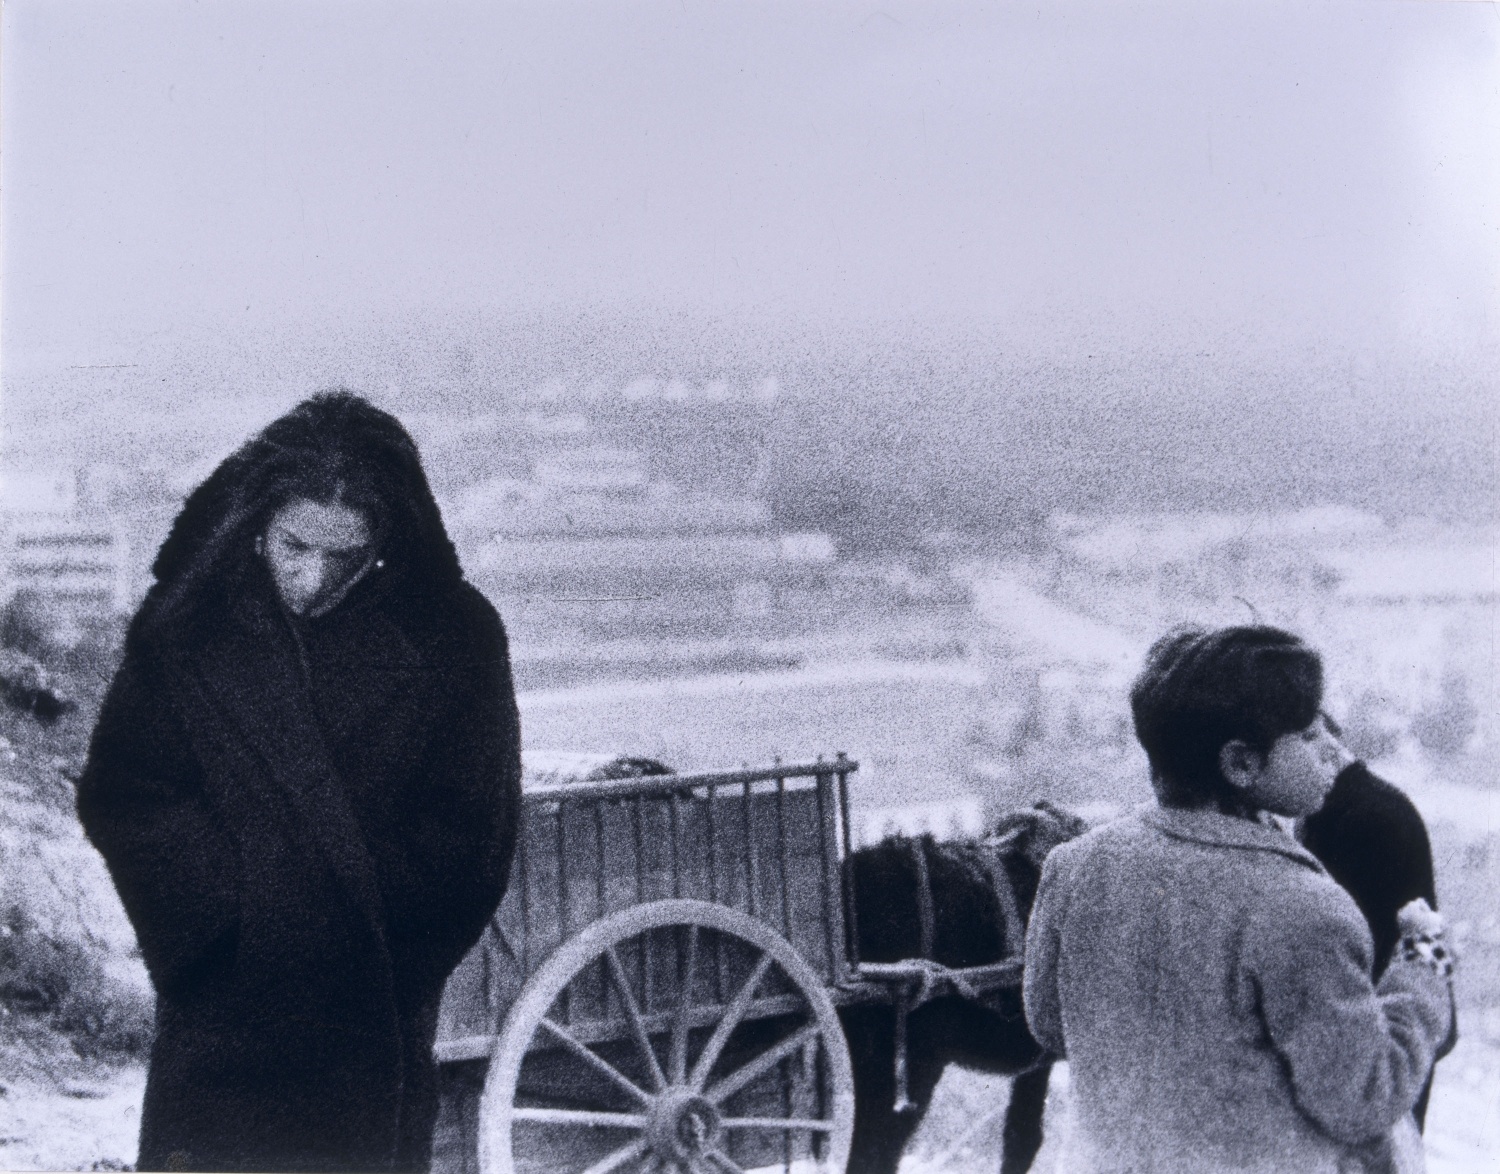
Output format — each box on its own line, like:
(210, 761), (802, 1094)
(78, 568), (521, 1171)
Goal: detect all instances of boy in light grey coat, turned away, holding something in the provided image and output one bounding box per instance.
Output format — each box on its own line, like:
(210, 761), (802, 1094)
(1023, 627), (1451, 1174)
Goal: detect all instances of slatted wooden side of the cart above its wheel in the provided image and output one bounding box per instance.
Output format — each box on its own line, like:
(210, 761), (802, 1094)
(438, 754), (858, 1060)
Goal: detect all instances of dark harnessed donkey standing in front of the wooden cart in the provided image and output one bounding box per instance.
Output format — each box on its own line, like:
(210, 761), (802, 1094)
(840, 802), (1086, 1174)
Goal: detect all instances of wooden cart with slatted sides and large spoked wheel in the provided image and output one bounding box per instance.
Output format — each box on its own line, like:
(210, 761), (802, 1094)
(434, 754), (1019, 1174)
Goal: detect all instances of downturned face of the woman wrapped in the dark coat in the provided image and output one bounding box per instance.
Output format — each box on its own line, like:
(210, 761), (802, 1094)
(263, 498), (375, 616)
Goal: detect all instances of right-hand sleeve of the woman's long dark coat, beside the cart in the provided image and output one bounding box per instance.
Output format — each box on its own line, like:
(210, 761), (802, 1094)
(398, 592), (521, 978)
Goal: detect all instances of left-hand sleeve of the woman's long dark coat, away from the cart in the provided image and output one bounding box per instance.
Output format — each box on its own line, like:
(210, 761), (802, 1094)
(78, 652), (239, 993)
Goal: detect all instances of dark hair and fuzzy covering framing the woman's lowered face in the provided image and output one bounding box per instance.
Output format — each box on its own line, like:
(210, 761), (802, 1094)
(141, 390), (462, 628)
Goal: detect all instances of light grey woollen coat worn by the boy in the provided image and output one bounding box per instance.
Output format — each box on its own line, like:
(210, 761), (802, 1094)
(1025, 808), (1451, 1174)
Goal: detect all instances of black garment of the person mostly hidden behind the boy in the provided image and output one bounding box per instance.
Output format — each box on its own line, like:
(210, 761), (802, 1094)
(1302, 762), (1437, 978)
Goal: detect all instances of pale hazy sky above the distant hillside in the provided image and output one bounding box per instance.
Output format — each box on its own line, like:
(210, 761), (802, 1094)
(0, 0), (1500, 374)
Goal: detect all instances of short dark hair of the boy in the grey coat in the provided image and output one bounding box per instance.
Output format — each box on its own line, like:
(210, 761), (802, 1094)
(1130, 627), (1323, 807)
